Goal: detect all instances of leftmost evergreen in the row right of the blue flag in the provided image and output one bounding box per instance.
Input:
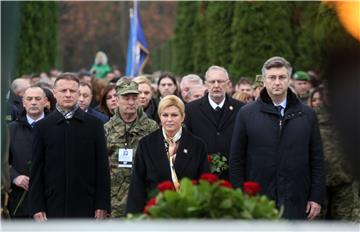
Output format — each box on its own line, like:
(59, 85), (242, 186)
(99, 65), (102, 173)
(173, 2), (198, 75)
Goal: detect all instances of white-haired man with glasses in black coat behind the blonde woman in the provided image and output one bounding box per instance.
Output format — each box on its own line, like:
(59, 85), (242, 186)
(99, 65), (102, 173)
(185, 66), (243, 180)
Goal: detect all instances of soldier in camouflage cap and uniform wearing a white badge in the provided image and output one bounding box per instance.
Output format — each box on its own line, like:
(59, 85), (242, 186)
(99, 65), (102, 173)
(105, 78), (158, 217)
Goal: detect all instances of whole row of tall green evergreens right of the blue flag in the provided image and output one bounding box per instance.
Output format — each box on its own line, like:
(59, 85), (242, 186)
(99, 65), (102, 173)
(146, 1), (360, 81)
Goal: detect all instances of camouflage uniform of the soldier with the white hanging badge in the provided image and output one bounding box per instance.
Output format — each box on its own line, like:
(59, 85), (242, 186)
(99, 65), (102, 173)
(104, 108), (158, 217)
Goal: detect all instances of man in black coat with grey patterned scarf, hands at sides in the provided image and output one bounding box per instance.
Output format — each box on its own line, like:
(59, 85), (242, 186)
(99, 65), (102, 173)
(29, 73), (110, 221)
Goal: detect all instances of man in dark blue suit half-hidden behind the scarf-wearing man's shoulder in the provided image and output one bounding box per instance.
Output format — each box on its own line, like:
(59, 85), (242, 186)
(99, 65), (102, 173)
(78, 82), (109, 124)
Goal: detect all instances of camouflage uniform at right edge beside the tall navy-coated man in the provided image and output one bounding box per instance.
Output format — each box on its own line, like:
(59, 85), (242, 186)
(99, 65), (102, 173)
(317, 108), (360, 222)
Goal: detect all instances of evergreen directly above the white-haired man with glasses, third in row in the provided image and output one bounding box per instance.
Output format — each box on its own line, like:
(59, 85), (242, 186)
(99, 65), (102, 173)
(206, 2), (235, 69)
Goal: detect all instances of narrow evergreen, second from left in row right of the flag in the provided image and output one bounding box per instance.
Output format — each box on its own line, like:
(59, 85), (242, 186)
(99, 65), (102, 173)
(193, 2), (209, 74)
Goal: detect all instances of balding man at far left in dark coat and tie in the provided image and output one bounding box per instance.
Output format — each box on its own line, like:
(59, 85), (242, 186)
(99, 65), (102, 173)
(9, 87), (46, 218)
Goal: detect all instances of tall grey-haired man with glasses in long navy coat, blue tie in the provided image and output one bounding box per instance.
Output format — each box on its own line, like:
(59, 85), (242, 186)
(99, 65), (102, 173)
(230, 57), (325, 219)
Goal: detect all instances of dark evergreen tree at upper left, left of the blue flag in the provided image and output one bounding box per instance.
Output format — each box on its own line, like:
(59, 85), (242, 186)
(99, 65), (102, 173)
(16, 2), (57, 75)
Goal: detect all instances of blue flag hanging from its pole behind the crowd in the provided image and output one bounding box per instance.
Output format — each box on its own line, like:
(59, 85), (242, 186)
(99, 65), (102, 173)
(125, 1), (150, 77)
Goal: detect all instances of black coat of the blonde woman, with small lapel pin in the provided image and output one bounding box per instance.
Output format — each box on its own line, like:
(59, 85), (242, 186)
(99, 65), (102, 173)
(126, 128), (209, 213)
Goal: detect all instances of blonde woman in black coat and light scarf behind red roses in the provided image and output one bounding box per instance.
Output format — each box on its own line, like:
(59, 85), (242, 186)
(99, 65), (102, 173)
(126, 95), (209, 213)
